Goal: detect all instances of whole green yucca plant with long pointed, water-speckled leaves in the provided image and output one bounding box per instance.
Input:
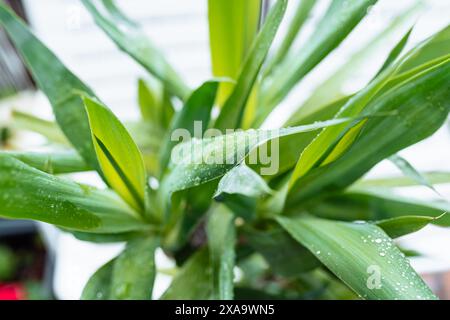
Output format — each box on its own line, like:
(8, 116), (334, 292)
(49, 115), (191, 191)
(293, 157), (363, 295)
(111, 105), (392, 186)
(0, 0), (450, 299)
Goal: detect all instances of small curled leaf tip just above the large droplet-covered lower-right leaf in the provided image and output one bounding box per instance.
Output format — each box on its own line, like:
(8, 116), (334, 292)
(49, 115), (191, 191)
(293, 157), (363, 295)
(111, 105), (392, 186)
(376, 216), (440, 239)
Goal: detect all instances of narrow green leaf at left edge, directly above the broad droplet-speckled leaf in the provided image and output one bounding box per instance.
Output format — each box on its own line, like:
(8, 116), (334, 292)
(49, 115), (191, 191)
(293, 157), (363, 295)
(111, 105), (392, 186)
(0, 151), (91, 174)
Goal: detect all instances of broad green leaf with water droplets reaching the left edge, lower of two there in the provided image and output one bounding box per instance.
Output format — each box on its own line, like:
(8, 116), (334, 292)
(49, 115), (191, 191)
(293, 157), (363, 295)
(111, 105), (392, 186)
(0, 154), (147, 233)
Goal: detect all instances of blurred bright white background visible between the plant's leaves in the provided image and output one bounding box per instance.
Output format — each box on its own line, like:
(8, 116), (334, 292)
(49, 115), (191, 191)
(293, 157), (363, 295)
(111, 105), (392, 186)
(5, 0), (450, 299)
